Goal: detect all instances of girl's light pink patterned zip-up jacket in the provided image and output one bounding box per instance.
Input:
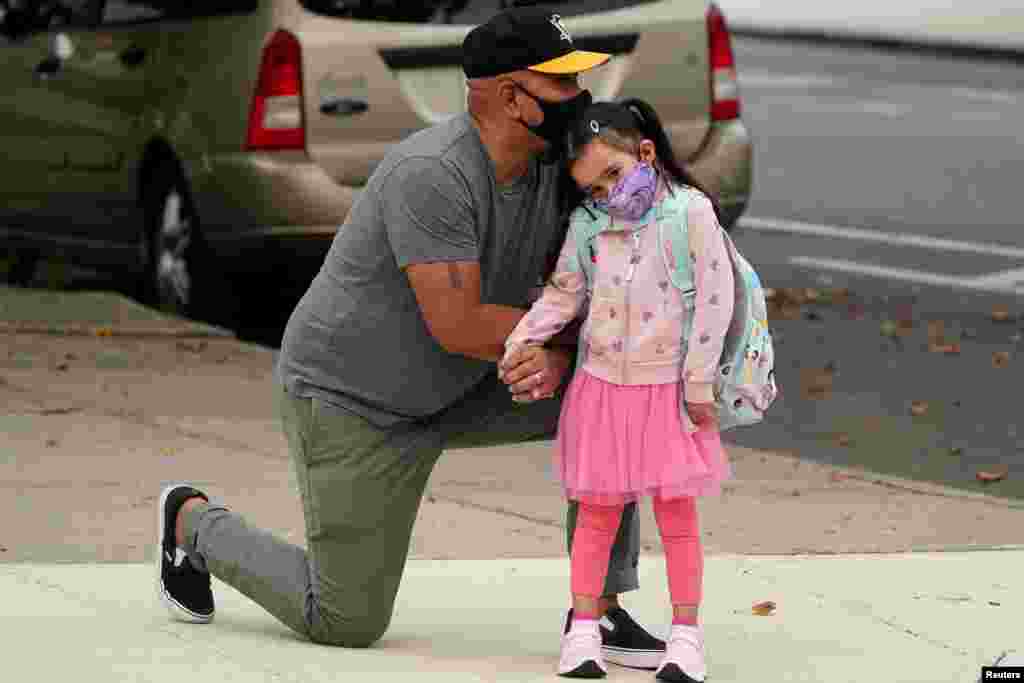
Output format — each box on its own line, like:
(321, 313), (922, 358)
(505, 185), (734, 402)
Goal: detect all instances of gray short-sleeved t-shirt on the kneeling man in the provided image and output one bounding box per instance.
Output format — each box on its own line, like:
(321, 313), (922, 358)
(278, 115), (561, 427)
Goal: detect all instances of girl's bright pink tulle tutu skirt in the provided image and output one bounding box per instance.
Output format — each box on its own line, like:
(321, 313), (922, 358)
(555, 370), (732, 505)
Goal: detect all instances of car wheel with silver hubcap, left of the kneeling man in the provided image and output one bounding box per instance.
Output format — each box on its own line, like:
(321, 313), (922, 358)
(143, 162), (238, 327)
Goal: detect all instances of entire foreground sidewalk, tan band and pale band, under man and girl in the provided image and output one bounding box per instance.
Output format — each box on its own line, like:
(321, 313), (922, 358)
(0, 288), (1024, 683)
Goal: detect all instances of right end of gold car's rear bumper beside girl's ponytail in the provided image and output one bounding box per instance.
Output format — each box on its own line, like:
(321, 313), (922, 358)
(688, 119), (754, 229)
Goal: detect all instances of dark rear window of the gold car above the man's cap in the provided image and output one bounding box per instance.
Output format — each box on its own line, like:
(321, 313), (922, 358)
(299, 0), (655, 25)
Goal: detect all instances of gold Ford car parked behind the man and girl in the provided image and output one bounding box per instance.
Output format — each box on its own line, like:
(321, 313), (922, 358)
(0, 0), (752, 319)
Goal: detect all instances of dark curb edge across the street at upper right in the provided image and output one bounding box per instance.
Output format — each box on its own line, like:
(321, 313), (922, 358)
(729, 22), (1024, 63)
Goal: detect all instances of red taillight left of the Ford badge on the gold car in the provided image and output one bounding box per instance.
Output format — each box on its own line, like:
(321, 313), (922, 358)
(246, 31), (306, 150)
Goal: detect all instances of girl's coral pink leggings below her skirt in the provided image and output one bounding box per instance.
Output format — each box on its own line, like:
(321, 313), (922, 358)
(571, 498), (703, 605)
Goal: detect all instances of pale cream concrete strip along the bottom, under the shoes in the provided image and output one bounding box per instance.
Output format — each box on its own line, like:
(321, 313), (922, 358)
(0, 551), (1024, 683)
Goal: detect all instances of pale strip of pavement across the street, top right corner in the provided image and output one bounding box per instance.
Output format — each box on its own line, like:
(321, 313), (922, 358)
(718, 0), (1024, 55)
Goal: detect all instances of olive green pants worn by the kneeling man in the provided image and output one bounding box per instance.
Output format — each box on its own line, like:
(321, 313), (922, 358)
(185, 374), (639, 647)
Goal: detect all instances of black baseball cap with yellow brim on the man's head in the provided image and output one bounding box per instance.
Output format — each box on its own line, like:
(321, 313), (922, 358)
(462, 7), (611, 78)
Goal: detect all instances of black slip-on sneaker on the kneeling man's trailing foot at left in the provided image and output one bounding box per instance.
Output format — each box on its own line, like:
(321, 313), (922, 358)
(157, 484), (213, 624)
